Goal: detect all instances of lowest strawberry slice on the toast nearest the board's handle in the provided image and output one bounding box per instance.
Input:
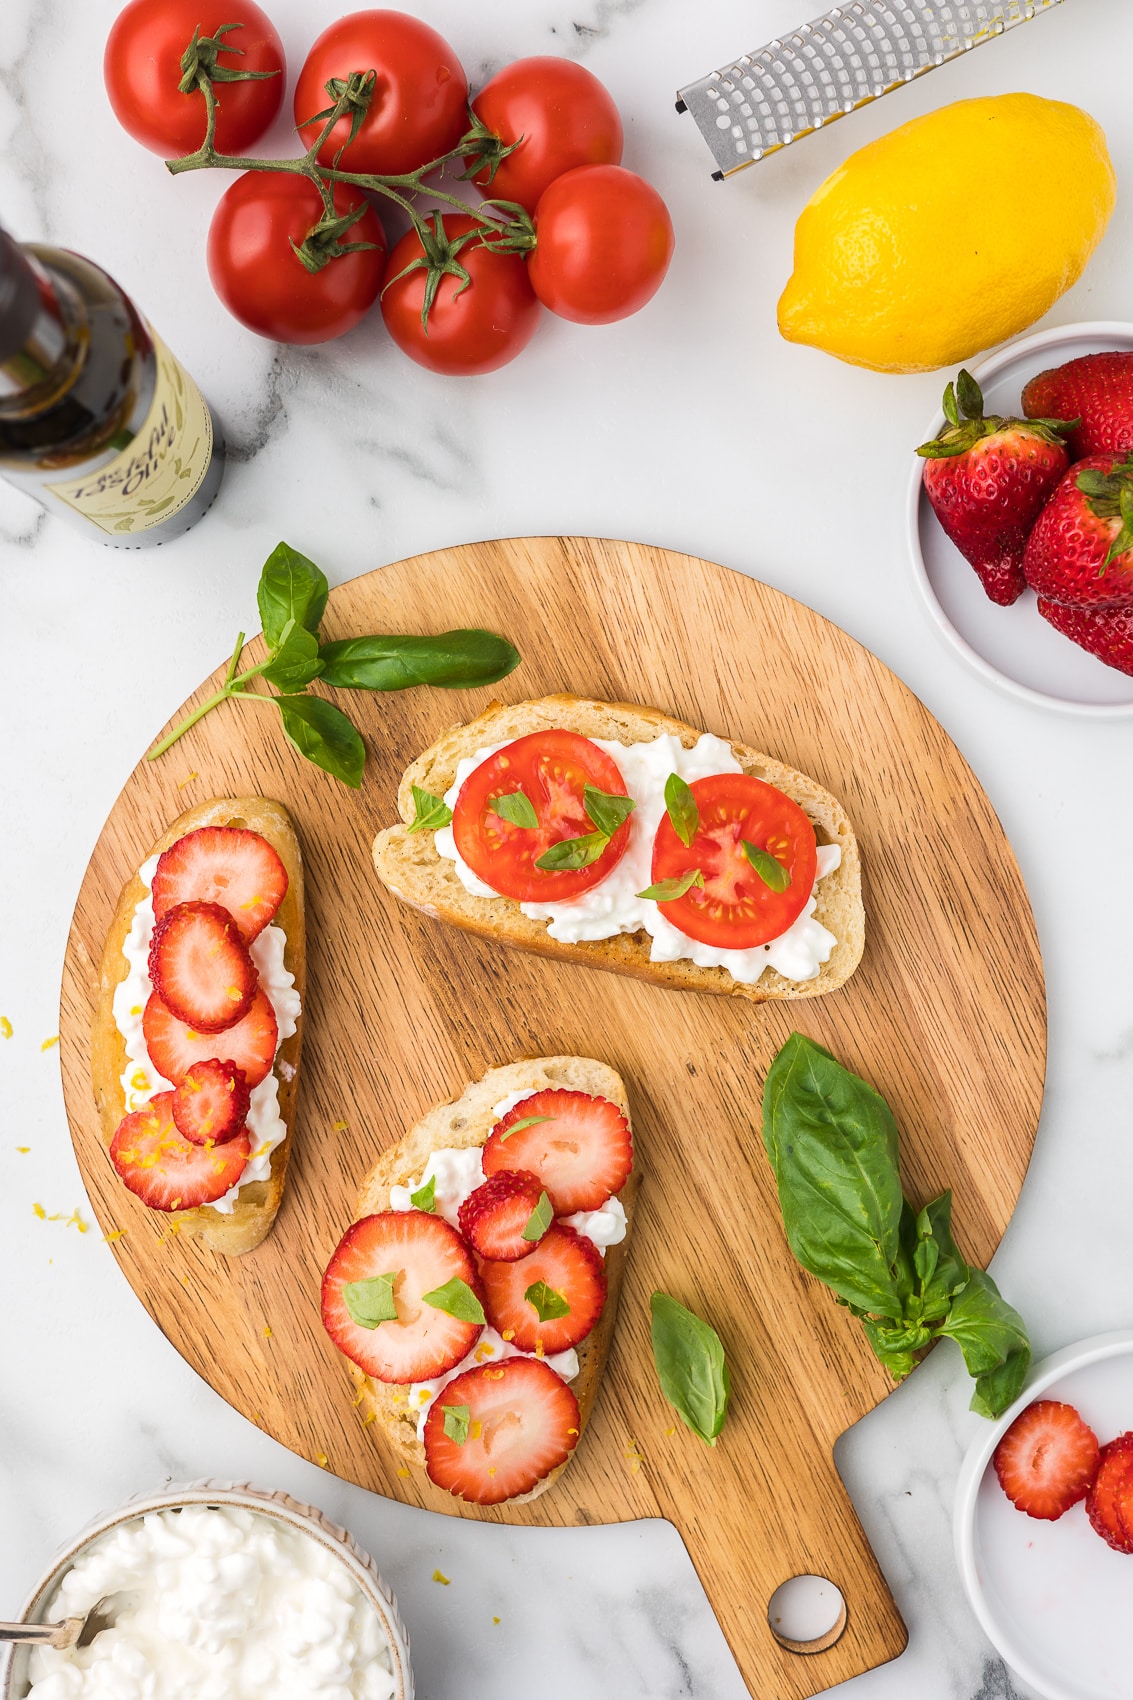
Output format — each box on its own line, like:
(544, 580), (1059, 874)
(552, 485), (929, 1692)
(425, 1358), (580, 1505)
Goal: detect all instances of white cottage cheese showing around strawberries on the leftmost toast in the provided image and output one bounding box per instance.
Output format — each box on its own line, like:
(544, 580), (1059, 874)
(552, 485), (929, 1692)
(114, 855), (301, 1216)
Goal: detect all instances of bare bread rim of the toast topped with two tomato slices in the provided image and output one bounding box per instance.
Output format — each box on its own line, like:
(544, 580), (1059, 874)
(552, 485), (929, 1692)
(374, 695), (866, 1003)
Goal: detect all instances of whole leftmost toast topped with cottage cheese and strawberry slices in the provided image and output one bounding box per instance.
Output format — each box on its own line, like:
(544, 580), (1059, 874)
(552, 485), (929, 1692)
(90, 797), (306, 1256)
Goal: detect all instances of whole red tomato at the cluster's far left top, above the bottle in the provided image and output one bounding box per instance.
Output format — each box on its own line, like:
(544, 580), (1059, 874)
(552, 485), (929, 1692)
(102, 0), (284, 158)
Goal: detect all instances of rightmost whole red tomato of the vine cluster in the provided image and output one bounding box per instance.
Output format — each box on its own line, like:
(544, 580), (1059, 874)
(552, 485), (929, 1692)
(527, 165), (674, 325)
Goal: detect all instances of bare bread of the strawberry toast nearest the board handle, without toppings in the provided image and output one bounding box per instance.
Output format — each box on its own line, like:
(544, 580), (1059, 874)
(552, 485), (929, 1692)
(349, 1057), (641, 1505)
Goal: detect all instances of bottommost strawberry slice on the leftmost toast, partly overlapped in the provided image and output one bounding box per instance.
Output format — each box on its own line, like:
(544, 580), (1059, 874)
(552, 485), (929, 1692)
(111, 1091), (250, 1210)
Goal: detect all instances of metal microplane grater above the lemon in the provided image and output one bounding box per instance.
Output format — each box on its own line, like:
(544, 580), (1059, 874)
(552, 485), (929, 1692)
(677, 0), (1062, 180)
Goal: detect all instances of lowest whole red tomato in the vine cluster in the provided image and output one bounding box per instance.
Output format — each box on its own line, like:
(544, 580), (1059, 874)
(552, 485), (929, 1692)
(381, 214), (543, 377)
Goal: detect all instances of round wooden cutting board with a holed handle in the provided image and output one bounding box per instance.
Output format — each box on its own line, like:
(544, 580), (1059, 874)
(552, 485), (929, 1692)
(61, 537), (1045, 1700)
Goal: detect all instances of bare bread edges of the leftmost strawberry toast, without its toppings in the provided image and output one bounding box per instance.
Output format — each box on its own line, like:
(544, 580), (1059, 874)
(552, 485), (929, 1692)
(90, 797), (306, 1256)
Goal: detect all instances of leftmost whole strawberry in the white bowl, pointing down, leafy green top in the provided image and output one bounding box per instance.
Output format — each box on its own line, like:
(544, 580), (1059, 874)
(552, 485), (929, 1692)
(917, 372), (1070, 607)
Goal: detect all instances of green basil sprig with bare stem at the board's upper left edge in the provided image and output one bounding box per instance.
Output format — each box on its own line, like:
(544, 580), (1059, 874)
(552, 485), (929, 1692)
(148, 542), (519, 785)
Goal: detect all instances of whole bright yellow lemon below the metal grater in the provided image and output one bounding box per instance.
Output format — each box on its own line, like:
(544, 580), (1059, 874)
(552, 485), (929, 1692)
(779, 95), (1116, 372)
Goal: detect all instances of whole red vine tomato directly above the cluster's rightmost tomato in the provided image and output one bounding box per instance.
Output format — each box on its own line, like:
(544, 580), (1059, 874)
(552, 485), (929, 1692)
(473, 56), (621, 213)
